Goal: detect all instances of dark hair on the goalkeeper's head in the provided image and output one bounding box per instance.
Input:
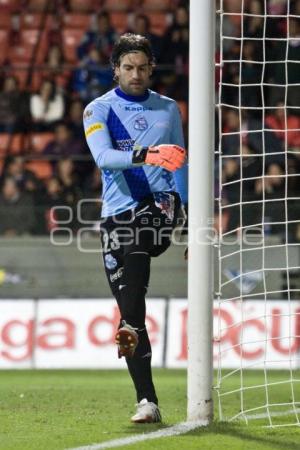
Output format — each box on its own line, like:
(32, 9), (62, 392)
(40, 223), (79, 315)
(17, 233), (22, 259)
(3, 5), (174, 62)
(110, 33), (155, 68)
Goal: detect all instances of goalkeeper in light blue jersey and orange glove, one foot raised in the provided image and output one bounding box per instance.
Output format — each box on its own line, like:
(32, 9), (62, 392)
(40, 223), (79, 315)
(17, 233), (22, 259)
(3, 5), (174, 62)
(83, 34), (187, 423)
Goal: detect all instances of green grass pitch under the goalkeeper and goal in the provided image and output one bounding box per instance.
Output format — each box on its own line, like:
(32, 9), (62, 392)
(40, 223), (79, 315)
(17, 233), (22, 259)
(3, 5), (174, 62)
(0, 369), (300, 450)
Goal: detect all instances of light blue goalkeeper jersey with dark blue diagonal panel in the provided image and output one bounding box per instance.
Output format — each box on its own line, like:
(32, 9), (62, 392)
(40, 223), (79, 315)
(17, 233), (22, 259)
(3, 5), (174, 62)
(83, 87), (187, 217)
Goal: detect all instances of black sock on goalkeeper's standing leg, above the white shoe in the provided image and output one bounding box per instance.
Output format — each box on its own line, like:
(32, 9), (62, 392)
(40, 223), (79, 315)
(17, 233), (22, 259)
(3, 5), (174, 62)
(126, 328), (158, 404)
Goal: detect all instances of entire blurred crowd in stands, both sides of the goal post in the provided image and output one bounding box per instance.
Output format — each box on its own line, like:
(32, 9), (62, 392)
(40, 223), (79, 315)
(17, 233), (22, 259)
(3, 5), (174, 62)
(0, 0), (300, 239)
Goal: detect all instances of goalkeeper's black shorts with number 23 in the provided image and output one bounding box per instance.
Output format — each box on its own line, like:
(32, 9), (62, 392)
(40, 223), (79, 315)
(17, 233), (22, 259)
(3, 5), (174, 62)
(100, 192), (181, 293)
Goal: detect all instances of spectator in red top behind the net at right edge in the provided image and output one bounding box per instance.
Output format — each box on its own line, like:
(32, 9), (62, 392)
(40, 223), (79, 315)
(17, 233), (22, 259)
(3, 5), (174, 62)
(266, 102), (300, 151)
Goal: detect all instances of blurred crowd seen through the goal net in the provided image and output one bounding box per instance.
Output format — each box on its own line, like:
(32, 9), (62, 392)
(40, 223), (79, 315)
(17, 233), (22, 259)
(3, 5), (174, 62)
(216, 0), (300, 241)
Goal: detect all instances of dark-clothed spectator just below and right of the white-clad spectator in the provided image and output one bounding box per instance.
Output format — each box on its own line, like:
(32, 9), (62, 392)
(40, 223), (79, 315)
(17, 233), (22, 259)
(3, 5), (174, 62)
(43, 122), (85, 158)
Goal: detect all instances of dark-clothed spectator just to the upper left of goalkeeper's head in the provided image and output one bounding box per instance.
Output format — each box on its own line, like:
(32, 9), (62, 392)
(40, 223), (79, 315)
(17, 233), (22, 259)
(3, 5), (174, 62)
(77, 12), (118, 60)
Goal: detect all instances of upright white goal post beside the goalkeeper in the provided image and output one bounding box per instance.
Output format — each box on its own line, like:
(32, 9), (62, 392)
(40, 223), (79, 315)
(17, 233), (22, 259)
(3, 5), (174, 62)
(188, 0), (215, 425)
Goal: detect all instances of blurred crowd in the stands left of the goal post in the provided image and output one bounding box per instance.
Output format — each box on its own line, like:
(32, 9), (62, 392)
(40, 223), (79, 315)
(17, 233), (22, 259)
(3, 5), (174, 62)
(0, 0), (189, 236)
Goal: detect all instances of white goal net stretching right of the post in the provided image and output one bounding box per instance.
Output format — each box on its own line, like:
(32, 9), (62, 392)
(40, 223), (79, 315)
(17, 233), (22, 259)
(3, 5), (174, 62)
(214, 0), (300, 427)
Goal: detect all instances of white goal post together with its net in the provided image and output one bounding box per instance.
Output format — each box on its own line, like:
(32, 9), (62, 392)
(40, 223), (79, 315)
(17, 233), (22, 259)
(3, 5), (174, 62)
(188, 0), (300, 427)
